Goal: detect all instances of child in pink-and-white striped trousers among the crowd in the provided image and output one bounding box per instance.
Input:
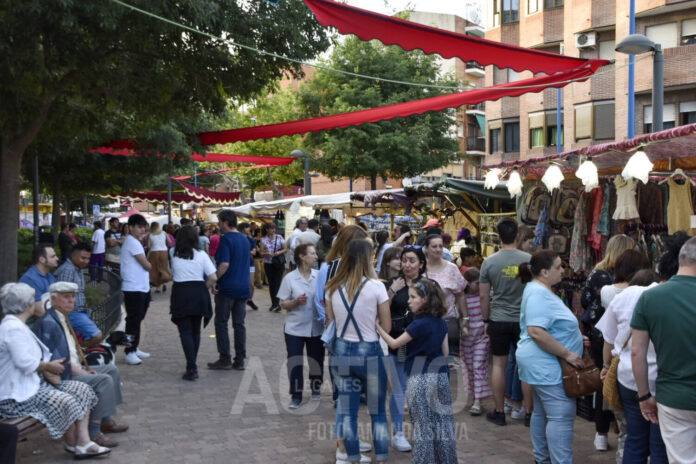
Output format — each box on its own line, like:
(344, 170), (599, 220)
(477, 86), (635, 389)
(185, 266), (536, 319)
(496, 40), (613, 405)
(459, 267), (492, 416)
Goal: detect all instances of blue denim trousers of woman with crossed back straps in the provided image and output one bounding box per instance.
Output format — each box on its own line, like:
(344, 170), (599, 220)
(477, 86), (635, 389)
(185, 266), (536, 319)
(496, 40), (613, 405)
(331, 338), (389, 462)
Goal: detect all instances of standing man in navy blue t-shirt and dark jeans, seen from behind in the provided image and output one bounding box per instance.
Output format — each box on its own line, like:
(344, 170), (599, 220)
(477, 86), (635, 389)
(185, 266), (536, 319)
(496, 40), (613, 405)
(208, 210), (251, 371)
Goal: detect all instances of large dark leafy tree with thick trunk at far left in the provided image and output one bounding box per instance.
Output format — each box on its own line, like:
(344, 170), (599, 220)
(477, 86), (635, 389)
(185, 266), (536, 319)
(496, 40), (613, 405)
(0, 0), (328, 283)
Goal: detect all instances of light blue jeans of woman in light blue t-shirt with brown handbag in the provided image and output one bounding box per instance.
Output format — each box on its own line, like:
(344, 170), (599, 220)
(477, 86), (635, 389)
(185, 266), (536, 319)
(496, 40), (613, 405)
(530, 383), (576, 464)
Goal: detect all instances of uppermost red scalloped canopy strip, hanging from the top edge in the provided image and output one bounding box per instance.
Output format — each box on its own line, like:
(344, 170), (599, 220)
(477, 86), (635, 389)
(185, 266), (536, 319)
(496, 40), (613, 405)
(304, 0), (603, 74)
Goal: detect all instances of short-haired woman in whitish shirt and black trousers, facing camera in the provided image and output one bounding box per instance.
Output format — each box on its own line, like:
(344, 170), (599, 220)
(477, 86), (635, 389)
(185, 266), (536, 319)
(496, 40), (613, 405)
(278, 243), (324, 409)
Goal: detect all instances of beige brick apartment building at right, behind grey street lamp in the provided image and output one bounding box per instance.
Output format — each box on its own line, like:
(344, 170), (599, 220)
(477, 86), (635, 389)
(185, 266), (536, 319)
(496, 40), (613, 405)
(485, 0), (696, 164)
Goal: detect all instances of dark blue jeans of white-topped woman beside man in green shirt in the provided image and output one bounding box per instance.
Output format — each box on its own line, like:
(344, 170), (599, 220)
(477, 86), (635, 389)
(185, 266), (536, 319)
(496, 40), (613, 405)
(619, 383), (667, 464)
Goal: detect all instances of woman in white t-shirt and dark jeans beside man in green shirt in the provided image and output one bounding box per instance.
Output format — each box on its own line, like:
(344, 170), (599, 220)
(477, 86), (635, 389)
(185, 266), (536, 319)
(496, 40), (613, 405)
(596, 270), (669, 464)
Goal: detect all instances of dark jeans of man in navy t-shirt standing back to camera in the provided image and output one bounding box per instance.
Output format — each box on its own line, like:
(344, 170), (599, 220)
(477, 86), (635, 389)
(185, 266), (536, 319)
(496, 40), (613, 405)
(215, 293), (246, 364)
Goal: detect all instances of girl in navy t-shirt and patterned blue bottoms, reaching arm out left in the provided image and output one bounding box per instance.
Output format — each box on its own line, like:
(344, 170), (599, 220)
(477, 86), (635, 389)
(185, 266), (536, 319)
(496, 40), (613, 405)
(377, 279), (458, 464)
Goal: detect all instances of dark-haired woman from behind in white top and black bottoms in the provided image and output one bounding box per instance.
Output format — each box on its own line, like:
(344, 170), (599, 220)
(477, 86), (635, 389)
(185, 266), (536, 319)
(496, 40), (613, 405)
(169, 226), (217, 380)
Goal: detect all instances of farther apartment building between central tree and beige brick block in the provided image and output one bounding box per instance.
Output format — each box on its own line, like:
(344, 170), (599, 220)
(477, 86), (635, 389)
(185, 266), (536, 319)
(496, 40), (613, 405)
(408, 11), (486, 181)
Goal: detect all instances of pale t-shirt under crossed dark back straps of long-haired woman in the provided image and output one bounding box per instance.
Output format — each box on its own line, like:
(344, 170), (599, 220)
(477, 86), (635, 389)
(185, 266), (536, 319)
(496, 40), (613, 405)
(331, 279), (389, 342)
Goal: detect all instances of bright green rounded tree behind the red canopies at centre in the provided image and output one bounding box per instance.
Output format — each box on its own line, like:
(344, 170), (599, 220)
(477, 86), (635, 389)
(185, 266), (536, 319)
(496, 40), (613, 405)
(300, 36), (458, 188)
